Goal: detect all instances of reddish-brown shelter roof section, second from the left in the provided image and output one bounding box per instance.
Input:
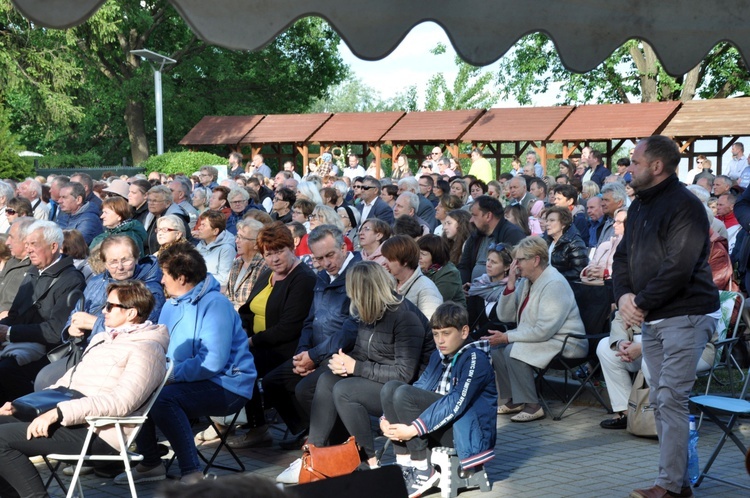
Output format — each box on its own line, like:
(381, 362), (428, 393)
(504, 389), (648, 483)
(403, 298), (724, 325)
(238, 113), (333, 145)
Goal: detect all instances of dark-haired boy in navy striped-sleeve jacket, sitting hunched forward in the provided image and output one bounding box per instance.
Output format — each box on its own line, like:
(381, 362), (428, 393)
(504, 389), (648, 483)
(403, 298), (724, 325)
(380, 301), (497, 498)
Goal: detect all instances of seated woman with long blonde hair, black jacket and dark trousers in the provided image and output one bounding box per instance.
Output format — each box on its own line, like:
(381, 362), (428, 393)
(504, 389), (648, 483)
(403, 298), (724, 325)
(279, 261), (434, 482)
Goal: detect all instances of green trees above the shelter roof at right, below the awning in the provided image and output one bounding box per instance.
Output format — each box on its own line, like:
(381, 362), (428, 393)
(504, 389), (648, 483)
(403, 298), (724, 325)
(497, 33), (750, 105)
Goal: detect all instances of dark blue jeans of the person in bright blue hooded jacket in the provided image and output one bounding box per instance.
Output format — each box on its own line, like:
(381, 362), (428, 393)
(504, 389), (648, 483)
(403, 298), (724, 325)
(136, 380), (248, 476)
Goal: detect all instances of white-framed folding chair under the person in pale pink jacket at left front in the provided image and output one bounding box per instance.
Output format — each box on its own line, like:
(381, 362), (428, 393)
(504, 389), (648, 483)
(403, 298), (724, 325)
(44, 359), (174, 498)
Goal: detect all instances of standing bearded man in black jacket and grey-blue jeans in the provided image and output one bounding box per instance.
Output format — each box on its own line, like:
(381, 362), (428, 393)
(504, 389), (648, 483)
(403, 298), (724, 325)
(613, 135), (719, 498)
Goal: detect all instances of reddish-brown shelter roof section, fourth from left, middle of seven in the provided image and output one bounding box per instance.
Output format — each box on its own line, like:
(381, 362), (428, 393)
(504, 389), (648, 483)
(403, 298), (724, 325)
(382, 109), (485, 143)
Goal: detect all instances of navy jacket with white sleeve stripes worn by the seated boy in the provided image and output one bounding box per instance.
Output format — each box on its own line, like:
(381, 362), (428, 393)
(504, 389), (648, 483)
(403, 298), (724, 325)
(412, 340), (497, 469)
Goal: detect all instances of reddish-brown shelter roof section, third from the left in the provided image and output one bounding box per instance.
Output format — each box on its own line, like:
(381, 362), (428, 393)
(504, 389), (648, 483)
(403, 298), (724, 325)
(310, 111), (406, 143)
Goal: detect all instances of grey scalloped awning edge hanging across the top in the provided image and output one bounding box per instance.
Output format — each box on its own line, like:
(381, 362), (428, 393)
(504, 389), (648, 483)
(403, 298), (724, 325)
(12, 0), (750, 75)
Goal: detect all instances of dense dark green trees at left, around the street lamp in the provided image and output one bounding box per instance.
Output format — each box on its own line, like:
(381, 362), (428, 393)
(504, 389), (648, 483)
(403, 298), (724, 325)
(0, 0), (347, 164)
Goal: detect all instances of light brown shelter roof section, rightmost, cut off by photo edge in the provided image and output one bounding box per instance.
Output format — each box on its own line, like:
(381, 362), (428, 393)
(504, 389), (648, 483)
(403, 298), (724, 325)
(662, 98), (750, 137)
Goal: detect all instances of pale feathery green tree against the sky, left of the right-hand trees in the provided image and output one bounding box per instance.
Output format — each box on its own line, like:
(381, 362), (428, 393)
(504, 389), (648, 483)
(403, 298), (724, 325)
(425, 44), (498, 111)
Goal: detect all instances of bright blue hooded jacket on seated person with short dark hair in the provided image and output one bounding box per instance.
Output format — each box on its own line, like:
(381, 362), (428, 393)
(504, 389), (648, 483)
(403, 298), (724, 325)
(159, 274), (257, 399)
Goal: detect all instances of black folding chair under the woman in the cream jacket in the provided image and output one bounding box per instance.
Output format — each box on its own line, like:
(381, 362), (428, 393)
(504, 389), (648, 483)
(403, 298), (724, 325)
(536, 280), (614, 420)
